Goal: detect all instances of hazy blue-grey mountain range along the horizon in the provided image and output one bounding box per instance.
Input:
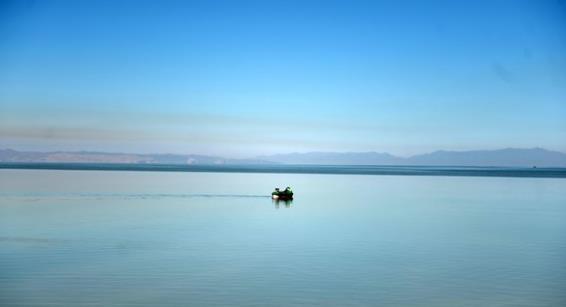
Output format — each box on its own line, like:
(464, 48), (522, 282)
(0, 148), (566, 167)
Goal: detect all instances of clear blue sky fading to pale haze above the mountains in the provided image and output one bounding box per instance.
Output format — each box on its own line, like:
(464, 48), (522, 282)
(0, 0), (566, 157)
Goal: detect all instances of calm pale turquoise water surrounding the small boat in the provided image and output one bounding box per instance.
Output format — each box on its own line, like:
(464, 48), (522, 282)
(0, 170), (566, 306)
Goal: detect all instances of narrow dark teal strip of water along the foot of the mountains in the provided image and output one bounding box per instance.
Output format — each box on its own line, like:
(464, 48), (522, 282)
(0, 162), (566, 178)
